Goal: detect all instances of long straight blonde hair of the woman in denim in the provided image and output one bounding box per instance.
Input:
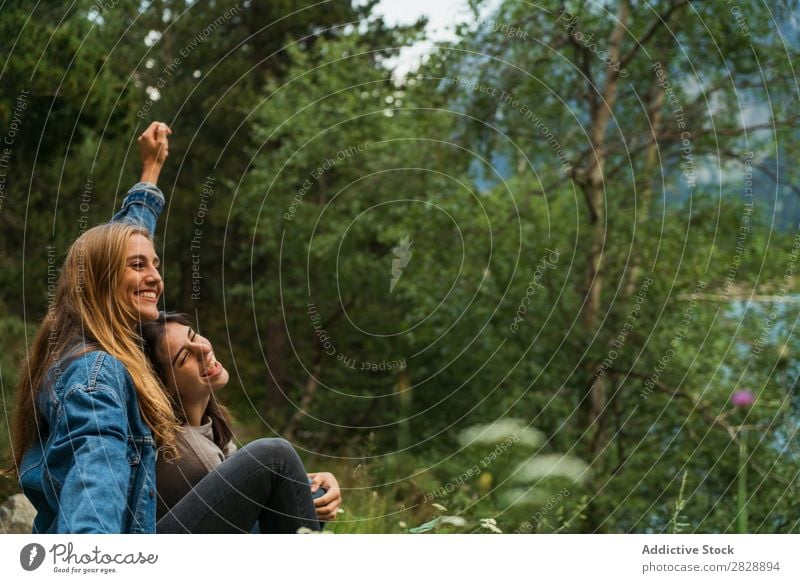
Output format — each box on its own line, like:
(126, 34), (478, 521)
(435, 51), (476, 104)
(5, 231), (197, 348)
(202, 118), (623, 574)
(6, 223), (178, 473)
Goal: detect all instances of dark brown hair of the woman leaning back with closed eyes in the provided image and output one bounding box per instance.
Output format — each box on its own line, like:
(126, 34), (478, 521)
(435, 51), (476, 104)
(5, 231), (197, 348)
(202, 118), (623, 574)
(142, 312), (233, 450)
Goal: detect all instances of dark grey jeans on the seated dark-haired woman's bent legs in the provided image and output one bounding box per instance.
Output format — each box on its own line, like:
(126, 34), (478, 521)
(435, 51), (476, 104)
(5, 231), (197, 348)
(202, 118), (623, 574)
(156, 438), (320, 533)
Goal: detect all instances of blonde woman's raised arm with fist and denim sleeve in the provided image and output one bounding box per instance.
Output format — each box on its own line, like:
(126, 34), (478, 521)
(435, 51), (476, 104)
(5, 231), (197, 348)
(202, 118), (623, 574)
(111, 121), (172, 235)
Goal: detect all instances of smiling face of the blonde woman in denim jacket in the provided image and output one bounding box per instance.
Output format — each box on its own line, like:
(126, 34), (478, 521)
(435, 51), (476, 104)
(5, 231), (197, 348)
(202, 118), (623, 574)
(119, 234), (164, 321)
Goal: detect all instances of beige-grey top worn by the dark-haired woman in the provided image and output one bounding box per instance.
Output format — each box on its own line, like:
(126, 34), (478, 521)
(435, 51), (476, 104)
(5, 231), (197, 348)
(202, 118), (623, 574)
(156, 417), (236, 518)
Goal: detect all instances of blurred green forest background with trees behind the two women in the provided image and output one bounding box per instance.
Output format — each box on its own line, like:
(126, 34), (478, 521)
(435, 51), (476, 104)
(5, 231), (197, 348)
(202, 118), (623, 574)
(0, 0), (800, 533)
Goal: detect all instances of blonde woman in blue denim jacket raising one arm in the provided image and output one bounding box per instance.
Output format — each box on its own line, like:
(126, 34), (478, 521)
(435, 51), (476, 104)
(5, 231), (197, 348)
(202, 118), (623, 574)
(10, 122), (178, 533)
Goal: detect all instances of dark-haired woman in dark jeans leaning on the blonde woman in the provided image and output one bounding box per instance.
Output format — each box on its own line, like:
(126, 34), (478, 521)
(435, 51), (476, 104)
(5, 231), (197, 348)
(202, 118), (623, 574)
(142, 313), (341, 533)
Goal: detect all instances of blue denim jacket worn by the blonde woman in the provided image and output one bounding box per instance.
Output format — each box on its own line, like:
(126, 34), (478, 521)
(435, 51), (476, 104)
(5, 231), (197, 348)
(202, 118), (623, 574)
(20, 183), (164, 533)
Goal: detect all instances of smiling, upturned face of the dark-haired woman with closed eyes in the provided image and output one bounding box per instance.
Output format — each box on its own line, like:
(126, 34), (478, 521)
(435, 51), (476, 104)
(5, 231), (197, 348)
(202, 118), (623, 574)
(158, 322), (230, 406)
